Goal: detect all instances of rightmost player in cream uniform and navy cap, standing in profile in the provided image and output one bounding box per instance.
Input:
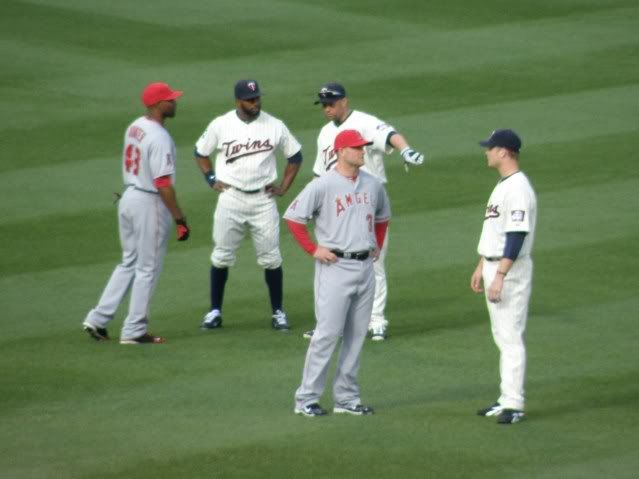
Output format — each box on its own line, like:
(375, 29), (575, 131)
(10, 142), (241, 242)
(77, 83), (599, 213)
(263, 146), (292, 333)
(470, 130), (537, 424)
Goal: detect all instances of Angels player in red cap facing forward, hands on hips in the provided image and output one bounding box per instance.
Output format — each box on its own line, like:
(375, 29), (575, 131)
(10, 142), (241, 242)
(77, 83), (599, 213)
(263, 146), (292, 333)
(284, 130), (390, 416)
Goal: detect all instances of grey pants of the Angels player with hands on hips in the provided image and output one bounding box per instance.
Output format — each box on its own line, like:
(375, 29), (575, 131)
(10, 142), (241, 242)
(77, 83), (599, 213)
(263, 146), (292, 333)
(295, 258), (375, 408)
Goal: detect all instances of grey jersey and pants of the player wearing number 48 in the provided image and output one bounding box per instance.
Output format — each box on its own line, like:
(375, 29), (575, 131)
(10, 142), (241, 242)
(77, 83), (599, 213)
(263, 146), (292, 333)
(85, 116), (175, 339)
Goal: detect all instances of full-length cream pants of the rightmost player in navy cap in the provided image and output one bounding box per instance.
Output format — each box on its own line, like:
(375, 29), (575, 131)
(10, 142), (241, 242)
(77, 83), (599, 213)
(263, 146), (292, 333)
(482, 256), (533, 410)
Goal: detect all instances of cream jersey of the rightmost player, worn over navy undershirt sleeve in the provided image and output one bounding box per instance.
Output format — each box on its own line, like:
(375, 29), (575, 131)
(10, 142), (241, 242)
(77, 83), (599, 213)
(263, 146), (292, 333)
(477, 171), (537, 258)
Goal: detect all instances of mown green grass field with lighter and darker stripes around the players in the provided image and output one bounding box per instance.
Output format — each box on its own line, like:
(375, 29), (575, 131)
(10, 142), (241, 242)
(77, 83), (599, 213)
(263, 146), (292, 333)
(0, 0), (639, 479)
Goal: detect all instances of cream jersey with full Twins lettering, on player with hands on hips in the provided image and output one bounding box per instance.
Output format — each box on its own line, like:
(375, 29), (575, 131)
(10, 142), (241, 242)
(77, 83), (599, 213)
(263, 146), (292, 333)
(195, 110), (302, 191)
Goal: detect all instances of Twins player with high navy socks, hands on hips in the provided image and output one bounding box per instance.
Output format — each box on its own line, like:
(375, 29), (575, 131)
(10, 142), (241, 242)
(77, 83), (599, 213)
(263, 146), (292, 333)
(195, 80), (302, 331)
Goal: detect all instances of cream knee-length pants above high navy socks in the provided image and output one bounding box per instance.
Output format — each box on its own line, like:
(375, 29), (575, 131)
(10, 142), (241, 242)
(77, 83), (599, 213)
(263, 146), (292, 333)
(211, 188), (282, 269)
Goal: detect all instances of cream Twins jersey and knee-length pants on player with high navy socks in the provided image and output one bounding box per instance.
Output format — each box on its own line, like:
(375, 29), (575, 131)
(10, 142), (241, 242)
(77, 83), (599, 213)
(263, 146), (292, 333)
(195, 110), (301, 269)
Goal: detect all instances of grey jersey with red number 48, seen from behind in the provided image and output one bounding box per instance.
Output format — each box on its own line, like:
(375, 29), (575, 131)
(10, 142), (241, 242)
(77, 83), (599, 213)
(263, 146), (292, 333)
(122, 116), (175, 192)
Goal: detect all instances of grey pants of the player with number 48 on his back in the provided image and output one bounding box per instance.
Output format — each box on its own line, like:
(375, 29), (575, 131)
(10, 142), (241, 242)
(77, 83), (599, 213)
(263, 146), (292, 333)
(85, 187), (171, 339)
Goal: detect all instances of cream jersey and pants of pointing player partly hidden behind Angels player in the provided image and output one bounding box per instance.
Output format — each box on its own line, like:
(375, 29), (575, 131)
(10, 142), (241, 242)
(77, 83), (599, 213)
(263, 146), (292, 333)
(313, 110), (395, 328)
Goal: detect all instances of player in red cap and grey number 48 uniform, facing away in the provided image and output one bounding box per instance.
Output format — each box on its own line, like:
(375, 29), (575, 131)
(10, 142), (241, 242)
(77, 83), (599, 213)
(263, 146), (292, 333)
(82, 83), (189, 344)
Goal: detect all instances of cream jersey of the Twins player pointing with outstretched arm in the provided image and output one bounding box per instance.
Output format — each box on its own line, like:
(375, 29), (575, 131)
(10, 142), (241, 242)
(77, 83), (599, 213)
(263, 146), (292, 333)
(313, 110), (395, 183)
